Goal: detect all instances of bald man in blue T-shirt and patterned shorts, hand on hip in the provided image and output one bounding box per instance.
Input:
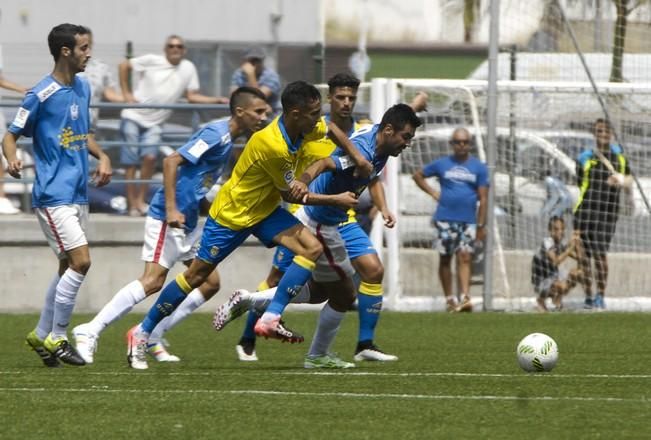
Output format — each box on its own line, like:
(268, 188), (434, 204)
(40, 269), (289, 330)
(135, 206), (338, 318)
(413, 128), (488, 312)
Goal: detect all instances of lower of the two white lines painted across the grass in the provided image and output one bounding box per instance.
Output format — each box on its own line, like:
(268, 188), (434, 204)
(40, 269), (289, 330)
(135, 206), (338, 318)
(0, 387), (651, 403)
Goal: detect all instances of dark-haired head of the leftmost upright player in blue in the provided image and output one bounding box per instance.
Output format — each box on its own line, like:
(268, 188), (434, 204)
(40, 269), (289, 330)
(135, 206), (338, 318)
(47, 23), (90, 73)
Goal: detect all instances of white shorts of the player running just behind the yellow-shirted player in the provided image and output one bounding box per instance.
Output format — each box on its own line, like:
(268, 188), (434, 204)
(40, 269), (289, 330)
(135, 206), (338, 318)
(141, 216), (201, 269)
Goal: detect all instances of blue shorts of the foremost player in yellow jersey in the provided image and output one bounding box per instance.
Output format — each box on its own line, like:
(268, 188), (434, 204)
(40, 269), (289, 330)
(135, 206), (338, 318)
(197, 207), (301, 265)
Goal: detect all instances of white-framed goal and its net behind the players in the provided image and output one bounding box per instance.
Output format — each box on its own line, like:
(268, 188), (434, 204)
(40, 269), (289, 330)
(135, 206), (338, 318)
(371, 79), (651, 310)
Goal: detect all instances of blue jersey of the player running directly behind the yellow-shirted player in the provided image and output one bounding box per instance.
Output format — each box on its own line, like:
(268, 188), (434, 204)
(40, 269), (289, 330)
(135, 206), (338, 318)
(147, 119), (233, 230)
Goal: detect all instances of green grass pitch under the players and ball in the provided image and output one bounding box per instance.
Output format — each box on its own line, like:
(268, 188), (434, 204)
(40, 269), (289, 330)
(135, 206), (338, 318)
(0, 312), (651, 439)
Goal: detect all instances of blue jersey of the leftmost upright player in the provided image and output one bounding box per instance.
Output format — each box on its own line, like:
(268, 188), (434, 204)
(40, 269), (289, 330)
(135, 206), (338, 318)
(9, 75), (90, 208)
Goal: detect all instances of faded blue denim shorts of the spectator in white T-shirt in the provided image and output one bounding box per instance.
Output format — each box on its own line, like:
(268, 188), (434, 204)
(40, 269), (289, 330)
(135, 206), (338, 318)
(120, 119), (162, 166)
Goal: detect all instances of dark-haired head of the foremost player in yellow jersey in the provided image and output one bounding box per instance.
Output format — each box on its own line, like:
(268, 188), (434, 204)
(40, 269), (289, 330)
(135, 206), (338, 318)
(280, 81), (321, 134)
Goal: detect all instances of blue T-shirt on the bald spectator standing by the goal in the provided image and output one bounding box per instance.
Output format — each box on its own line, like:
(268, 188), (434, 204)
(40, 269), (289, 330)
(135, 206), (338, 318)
(423, 156), (488, 223)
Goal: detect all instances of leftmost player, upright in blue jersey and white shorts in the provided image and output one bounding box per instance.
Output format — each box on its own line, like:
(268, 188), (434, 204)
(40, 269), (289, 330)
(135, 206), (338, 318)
(2, 23), (112, 367)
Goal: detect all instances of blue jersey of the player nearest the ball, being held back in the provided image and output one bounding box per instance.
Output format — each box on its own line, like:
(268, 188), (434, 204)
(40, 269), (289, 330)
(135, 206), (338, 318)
(305, 125), (388, 225)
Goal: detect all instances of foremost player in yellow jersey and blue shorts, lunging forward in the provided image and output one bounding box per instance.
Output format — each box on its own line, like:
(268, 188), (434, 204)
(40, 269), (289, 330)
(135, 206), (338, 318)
(127, 81), (371, 369)
